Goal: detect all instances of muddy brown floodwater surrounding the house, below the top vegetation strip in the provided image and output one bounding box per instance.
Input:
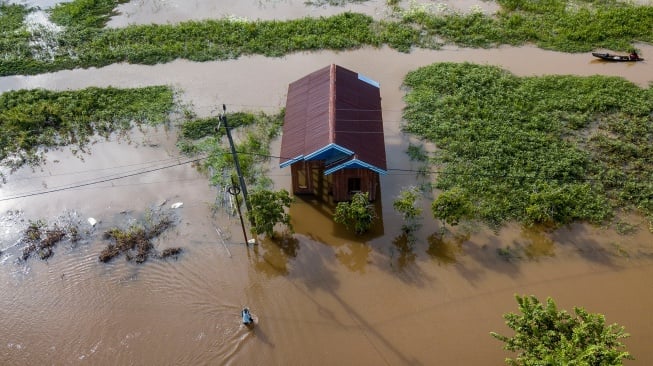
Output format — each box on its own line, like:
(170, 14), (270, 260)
(0, 2), (653, 365)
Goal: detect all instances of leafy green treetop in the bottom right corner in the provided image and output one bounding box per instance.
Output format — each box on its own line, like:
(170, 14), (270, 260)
(490, 295), (633, 366)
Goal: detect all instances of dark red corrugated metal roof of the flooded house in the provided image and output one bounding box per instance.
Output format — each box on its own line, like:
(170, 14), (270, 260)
(281, 65), (386, 170)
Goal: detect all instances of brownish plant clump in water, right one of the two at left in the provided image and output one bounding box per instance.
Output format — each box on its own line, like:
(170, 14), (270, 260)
(98, 214), (181, 264)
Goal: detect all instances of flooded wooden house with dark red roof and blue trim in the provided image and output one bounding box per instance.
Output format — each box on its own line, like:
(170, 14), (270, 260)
(280, 64), (387, 202)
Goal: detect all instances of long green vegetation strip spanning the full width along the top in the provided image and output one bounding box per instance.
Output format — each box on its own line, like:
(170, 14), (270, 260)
(0, 0), (653, 76)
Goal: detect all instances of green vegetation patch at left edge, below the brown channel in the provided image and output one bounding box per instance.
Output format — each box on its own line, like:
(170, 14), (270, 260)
(0, 86), (175, 169)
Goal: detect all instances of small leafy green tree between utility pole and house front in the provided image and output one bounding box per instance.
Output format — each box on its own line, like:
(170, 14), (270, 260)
(247, 189), (292, 238)
